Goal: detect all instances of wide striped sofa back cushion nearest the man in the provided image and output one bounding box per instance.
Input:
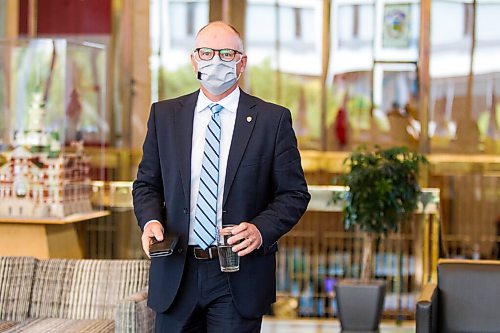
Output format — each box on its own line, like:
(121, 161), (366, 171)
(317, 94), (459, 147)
(29, 259), (149, 319)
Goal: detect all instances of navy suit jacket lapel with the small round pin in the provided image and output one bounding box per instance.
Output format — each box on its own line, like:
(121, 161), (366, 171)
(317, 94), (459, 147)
(222, 91), (257, 207)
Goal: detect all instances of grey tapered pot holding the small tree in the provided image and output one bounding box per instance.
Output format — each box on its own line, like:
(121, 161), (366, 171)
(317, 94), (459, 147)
(335, 279), (386, 333)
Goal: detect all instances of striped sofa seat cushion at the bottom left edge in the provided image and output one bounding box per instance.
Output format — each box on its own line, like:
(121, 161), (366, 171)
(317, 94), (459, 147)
(3, 318), (115, 333)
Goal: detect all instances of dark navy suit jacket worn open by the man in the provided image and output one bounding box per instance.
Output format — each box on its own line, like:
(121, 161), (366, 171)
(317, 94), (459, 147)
(133, 91), (310, 318)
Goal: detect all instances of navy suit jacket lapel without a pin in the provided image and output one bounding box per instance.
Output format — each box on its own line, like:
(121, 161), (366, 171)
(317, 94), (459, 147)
(173, 90), (199, 205)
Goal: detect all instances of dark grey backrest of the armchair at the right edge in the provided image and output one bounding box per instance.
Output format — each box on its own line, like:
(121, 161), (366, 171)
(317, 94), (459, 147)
(438, 261), (500, 333)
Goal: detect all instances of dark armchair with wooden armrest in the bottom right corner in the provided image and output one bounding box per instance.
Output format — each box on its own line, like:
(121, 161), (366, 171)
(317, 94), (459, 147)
(416, 260), (500, 333)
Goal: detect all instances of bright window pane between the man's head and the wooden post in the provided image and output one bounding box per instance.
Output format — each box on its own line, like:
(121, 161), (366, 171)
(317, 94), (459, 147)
(245, 0), (323, 149)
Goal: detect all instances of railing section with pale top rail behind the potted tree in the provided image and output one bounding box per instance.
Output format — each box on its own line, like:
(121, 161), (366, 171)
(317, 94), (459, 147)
(274, 186), (439, 318)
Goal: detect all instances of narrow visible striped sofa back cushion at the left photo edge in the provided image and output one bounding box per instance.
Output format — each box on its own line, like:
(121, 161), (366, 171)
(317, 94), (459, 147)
(0, 257), (36, 321)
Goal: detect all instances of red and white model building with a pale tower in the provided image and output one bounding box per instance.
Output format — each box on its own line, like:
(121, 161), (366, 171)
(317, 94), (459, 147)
(0, 93), (92, 218)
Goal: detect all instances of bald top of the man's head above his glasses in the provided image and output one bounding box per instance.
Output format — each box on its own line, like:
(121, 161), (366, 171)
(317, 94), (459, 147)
(196, 21), (243, 53)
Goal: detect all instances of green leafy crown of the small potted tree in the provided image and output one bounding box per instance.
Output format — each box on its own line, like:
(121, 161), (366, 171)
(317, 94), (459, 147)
(341, 147), (427, 236)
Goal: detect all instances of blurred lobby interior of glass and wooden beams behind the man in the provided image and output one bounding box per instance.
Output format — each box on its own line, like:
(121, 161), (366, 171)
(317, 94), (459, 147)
(0, 0), (500, 328)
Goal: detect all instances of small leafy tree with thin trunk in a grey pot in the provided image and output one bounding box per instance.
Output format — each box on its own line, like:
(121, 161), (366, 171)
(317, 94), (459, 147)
(334, 147), (427, 332)
